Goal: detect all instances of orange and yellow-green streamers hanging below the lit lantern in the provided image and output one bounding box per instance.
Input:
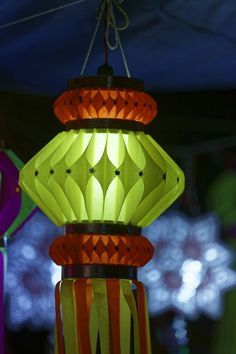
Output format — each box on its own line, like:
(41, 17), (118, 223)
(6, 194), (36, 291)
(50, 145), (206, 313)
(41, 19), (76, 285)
(55, 278), (151, 354)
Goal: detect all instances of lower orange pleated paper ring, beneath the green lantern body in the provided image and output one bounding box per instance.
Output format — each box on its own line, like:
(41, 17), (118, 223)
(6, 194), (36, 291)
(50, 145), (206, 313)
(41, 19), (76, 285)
(49, 234), (153, 267)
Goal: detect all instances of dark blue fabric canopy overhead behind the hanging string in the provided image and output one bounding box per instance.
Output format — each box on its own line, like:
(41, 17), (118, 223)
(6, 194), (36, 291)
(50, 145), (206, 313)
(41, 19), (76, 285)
(0, 0), (236, 94)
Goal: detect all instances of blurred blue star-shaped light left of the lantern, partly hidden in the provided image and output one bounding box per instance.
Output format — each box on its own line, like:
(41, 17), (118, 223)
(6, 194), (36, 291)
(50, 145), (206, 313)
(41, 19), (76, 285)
(6, 210), (62, 330)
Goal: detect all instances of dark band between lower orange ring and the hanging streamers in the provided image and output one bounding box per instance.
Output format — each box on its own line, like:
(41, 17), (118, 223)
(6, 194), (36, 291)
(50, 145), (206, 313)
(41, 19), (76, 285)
(62, 264), (137, 280)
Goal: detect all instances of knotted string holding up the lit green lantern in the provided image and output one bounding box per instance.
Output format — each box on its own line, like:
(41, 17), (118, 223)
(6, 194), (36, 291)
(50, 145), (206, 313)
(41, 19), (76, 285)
(80, 0), (130, 77)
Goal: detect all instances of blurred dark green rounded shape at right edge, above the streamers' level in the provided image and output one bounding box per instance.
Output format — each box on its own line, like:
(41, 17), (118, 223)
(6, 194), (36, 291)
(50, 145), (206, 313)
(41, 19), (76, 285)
(207, 170), (236, 228)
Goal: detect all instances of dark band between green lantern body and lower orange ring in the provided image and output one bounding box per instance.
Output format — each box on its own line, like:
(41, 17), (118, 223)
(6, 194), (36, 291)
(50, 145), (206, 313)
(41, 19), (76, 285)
(65, 223), (142, 236)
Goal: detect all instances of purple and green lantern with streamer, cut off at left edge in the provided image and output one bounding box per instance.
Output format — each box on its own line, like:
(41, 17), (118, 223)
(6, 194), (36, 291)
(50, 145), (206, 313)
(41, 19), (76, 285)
(0, 149), (35, 353)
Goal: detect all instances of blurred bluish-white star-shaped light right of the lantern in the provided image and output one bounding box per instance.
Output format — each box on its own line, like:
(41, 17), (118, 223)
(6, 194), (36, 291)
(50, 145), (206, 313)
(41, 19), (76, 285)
(139, 212), (236, 319)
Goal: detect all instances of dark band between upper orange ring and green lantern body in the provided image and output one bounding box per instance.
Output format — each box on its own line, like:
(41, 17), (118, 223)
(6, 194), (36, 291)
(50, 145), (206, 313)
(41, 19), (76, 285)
(66, 118), (145, 131)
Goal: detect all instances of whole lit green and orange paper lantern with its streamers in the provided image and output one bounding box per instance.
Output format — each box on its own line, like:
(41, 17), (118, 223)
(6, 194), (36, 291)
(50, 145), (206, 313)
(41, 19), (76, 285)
(20, 76), (184, 354)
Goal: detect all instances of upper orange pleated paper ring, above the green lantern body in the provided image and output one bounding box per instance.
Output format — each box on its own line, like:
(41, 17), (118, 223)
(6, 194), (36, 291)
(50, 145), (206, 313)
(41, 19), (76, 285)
(54, 88), (158, 124)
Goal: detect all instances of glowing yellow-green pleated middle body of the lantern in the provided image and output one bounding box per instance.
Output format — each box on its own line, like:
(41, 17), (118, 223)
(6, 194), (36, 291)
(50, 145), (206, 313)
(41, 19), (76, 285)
(20, 129), (184, 227)
